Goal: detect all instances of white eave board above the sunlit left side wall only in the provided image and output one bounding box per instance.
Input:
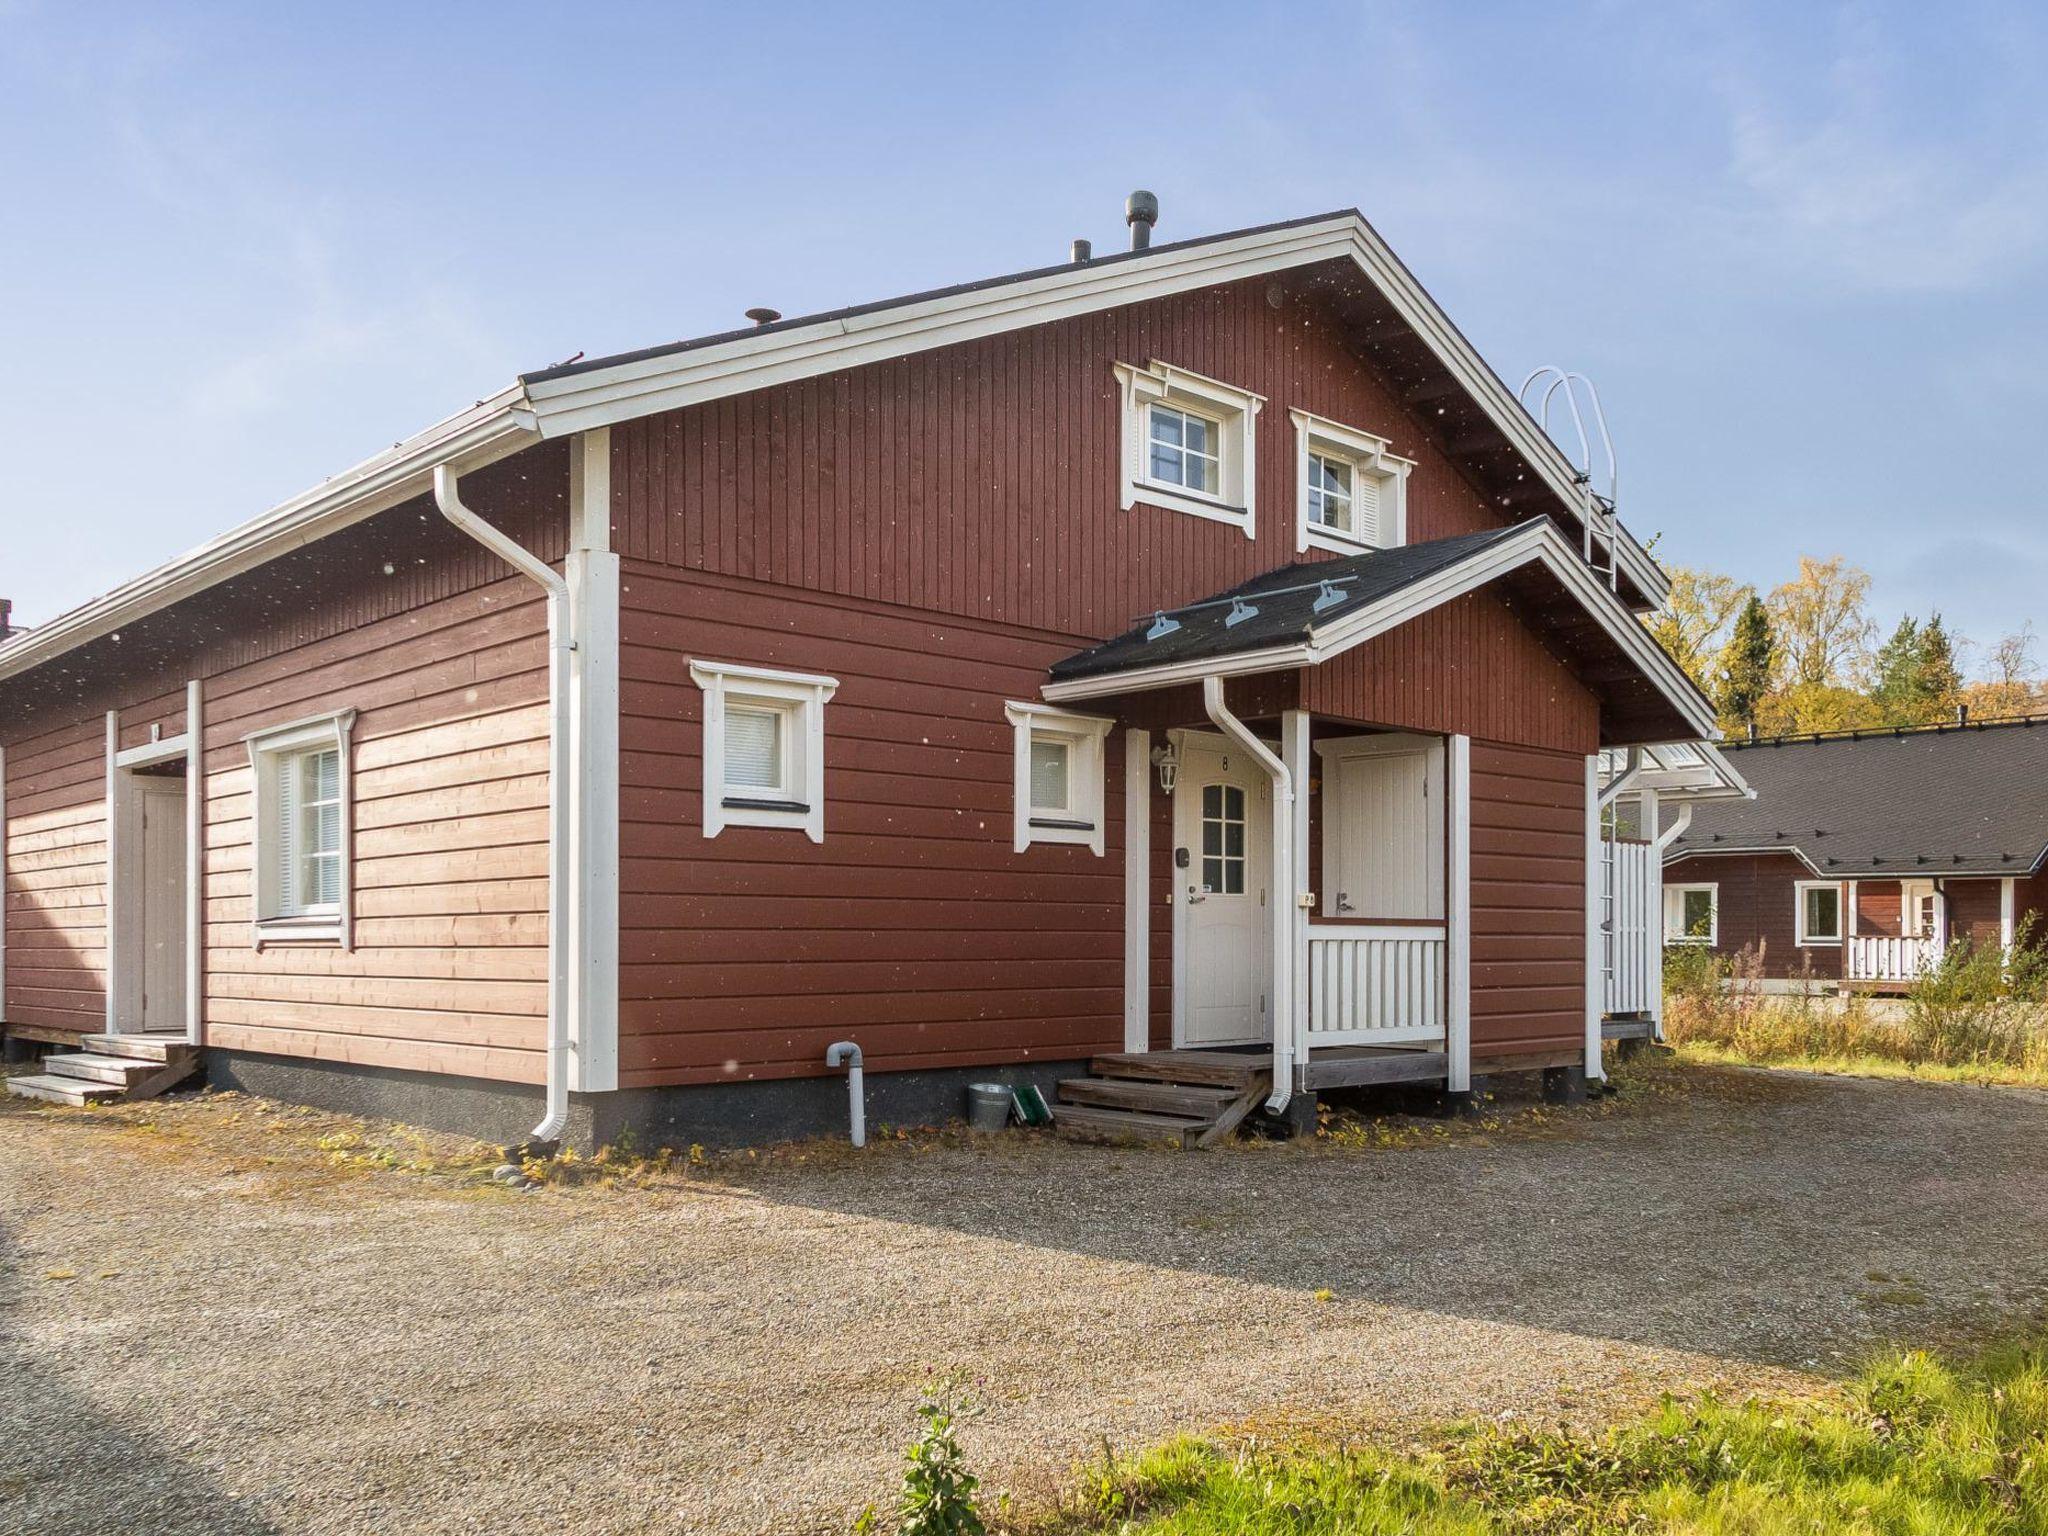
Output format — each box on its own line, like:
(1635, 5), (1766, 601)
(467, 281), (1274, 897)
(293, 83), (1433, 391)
(0, 387), (541, 678)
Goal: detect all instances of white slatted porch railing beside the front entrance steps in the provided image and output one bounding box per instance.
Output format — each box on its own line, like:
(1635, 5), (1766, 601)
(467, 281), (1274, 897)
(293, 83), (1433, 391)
(1309, 924), (1446, 1049)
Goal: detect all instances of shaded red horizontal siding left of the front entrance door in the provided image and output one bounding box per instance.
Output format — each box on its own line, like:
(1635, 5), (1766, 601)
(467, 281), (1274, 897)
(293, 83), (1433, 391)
(618, 561), (1146, 1087)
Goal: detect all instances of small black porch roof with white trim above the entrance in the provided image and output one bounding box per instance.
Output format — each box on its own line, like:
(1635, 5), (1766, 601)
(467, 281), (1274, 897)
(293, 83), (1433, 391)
(1042, 518), (1714, 741)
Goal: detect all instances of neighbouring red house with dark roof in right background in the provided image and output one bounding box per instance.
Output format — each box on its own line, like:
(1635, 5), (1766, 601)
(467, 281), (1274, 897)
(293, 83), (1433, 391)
(1665, 719), (2048, 989)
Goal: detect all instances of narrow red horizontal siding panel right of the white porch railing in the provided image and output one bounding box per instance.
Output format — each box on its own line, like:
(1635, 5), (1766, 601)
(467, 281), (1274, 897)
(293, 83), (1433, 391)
(1473, 741), (1587, 1061)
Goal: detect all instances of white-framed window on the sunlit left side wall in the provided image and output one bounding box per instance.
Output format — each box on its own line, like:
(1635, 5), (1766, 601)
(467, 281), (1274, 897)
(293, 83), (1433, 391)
(248, 711), (354, 944)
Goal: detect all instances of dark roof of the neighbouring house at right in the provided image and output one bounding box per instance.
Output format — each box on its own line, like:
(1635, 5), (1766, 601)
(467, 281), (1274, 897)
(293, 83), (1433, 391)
(1665, 719), (2048, 881)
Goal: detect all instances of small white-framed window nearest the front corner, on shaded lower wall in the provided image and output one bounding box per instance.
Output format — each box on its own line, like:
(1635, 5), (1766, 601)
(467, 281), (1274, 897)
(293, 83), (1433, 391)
(690, 662), (840, 842)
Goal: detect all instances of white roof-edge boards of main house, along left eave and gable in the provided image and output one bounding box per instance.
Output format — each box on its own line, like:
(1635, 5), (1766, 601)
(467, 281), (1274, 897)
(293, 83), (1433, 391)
(0, 209), (1669, 678)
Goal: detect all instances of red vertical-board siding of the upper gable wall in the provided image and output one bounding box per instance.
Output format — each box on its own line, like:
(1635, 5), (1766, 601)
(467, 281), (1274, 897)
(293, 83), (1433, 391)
(612, 279), (1501, 639)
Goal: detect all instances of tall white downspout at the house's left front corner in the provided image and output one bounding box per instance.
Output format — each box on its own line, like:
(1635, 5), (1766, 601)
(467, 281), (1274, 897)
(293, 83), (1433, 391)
(434, 465), (575, 1145)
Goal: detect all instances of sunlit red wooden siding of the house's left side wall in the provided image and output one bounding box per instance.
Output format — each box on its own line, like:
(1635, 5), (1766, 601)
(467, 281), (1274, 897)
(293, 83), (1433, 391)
(0, 449), (567, 1081)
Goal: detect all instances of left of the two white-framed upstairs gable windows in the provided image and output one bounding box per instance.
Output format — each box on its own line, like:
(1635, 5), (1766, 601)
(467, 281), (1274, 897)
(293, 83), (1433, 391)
(1116, 362), (1264, 539)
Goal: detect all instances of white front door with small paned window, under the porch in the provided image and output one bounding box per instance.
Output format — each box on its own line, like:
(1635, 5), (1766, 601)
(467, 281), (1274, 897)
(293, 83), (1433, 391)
(1174, 735), (1272, 1044)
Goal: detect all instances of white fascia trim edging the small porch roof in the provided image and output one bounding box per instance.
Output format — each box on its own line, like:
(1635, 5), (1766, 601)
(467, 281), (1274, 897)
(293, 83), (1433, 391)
(1040, 518), (1716, 735)
